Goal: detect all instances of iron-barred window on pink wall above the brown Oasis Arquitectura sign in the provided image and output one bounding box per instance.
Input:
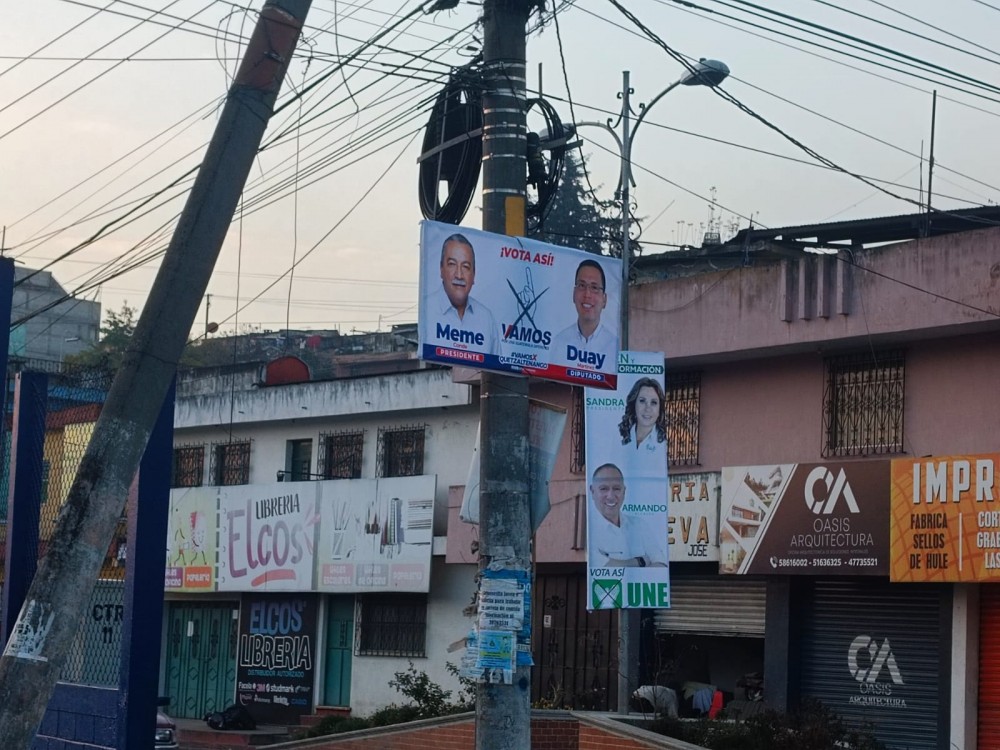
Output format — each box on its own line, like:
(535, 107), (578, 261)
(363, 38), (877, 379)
(823, 350), (905, 457)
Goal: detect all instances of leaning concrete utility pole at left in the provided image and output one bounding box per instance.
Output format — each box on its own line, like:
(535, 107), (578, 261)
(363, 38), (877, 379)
(0, 0), (310, 750)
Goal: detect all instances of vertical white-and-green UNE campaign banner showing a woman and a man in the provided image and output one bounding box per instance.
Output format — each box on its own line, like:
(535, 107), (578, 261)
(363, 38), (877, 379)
(585, 352), (670, 610)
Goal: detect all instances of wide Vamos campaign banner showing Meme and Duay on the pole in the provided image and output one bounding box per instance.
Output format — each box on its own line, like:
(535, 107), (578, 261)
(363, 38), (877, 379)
(418, 221), (621, 389)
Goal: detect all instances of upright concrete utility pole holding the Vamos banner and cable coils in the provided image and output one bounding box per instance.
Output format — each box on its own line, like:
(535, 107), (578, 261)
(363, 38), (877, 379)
(476, 0), (534, 750)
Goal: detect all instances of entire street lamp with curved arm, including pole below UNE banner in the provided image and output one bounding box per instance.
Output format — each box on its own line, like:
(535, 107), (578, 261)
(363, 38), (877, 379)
(576, 58), (729, 714)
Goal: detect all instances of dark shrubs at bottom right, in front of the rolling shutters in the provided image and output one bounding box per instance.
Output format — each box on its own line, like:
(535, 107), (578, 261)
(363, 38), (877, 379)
(651, 701), (885, 750)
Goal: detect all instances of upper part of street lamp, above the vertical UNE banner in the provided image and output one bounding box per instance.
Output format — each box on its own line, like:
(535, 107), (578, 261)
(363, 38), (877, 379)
(576, 57), (729, 349)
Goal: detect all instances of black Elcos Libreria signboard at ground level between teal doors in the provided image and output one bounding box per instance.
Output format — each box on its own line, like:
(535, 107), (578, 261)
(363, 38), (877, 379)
(236, 594), (317, 724)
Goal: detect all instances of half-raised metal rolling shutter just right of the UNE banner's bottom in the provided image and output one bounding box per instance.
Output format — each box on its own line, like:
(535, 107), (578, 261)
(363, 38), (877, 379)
(653, 576), (767, 638)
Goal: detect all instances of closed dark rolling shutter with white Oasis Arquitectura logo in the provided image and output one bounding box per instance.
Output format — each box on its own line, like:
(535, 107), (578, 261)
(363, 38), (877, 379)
(800, 580), (948, 750)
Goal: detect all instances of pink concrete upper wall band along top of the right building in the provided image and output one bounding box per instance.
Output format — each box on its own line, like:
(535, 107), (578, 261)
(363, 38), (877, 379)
(629, 229), (1000, 364)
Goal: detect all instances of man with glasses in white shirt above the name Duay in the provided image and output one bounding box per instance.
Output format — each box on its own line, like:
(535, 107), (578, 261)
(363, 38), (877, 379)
(551, 259), (618, 371)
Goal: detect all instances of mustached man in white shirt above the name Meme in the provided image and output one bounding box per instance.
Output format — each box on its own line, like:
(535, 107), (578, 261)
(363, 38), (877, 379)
(429, 233), (498, 354)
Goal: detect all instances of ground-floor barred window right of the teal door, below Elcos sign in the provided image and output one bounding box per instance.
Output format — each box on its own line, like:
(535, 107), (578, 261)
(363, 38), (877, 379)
(355, 594), (427, 656)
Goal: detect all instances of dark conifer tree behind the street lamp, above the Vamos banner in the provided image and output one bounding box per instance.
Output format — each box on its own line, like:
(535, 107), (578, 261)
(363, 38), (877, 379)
(532, 151), (639, 258)
